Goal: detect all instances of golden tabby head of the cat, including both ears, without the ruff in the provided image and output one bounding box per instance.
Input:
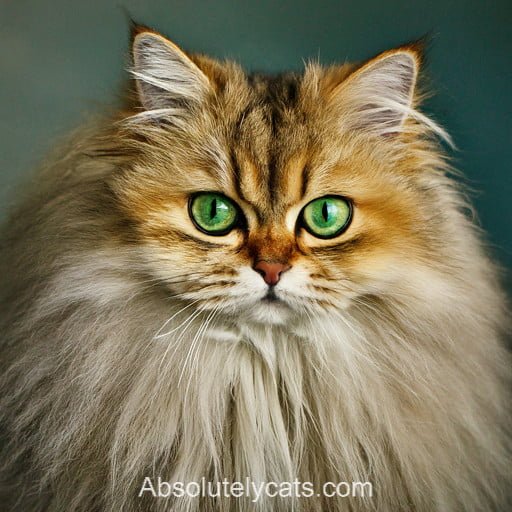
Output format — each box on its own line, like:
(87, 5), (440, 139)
(113, 31), (448, 324)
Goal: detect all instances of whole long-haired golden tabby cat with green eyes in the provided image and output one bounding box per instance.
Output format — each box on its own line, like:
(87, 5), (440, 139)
(0, 26), (510, 512)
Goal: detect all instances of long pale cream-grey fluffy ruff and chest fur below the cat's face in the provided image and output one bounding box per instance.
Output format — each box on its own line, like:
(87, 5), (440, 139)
(2, 225), (509, 512)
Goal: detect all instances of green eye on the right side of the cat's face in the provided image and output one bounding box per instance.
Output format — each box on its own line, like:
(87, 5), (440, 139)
(302, 196), (352, 238)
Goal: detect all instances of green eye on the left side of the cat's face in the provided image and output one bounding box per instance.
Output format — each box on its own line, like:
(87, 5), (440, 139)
(189, 192), (238, 236)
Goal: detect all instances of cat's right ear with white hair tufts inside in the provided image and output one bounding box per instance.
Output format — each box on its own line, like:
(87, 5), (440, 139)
(331, 48), (420, 135)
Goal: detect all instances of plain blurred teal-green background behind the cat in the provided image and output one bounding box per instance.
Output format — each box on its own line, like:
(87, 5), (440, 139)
(0, 0), (512, 280)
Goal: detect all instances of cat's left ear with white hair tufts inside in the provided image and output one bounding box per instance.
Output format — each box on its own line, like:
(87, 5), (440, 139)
(131, 29), (211, 111)
